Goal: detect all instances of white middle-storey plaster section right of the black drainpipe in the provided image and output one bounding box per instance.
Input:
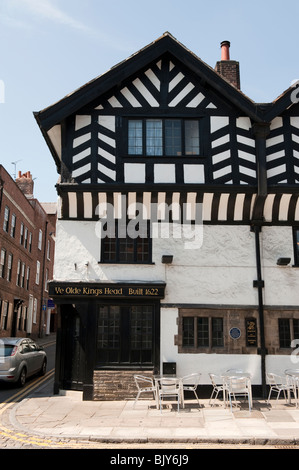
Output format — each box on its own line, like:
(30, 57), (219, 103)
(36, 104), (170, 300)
(261, 226), (299, 306)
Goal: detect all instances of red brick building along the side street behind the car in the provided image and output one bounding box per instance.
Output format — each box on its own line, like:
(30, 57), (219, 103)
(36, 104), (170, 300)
(0, 165), (56, 338)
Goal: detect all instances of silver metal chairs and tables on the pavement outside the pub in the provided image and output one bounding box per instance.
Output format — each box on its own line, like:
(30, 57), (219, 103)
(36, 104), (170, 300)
(134, 369), (299, 413)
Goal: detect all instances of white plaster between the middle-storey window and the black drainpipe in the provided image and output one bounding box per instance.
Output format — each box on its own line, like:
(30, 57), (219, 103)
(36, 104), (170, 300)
(153, 225), (257, 305)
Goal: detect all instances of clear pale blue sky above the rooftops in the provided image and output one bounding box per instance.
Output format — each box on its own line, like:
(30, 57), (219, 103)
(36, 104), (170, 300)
(0, 0), (299, 202)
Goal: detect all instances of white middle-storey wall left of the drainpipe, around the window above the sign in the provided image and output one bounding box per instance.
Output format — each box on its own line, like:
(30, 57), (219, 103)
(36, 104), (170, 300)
(54, 220), (257, 305)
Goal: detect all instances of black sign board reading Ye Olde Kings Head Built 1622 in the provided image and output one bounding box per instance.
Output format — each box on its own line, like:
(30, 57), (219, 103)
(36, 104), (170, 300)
(49, 281), (165, 299)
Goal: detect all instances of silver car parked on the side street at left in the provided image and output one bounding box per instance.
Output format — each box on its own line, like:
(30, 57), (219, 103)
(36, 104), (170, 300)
(0, 338), (47, 387)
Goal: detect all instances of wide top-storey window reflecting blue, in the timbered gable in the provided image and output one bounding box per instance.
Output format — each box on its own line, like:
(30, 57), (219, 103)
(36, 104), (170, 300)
(128, 119), (200, 157)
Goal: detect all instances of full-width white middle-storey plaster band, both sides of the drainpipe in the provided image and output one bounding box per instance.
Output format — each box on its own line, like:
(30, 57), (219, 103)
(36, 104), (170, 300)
(54, 220), (299, 306)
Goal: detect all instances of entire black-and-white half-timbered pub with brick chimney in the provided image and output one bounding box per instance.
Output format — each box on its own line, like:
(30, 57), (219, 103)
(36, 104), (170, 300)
(35, 33), (299, 399)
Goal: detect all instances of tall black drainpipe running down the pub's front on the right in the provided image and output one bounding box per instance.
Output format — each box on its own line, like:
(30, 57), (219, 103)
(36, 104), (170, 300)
(251, 123), (270, 398)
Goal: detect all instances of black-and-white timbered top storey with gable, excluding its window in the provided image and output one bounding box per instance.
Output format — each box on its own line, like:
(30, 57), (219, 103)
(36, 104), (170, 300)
(35, 33), (299, 228)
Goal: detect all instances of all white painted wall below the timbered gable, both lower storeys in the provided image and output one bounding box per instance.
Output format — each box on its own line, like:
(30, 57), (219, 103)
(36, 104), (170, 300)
(54, 220), (299, 384)
